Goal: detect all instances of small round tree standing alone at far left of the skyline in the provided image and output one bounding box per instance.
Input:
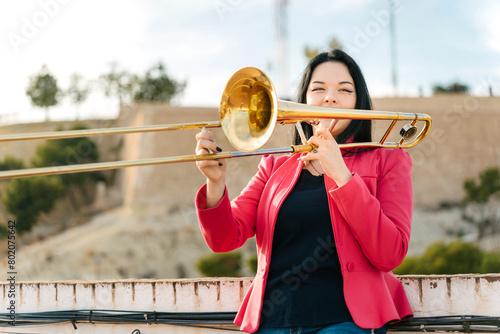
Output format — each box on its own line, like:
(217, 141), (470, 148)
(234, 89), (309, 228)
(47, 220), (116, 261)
(26, 65), (61, 121)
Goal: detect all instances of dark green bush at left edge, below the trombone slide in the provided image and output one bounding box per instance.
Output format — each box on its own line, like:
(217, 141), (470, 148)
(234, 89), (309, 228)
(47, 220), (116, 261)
(2, 176), (64, 233)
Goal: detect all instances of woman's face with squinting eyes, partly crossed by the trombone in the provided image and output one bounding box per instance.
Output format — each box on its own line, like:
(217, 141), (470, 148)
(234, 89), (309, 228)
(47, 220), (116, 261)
(306, 61), (356, 137)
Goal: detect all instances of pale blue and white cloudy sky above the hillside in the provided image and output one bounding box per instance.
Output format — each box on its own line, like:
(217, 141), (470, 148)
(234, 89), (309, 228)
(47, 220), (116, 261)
(0, 0), (500, 124)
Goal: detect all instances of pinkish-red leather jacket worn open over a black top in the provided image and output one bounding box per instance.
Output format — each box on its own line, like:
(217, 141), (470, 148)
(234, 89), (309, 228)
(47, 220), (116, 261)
(196, 149), (413, 333)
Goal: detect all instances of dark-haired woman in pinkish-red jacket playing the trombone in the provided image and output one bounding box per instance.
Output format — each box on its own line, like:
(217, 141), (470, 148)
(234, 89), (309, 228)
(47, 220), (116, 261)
(196, 50), (413, 334)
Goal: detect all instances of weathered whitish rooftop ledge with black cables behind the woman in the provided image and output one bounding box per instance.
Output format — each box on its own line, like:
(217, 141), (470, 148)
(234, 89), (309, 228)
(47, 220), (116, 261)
(0, 274), (500, 334)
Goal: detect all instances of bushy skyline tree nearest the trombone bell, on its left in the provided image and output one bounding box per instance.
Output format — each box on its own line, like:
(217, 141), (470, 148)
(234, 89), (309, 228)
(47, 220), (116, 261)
(134, 62), (186, 103)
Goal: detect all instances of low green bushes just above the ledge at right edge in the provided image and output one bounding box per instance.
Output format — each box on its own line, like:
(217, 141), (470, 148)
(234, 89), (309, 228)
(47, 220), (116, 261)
(394, 240), (500, 275)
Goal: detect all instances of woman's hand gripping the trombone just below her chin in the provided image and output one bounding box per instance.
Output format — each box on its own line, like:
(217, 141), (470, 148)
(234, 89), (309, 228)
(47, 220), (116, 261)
(301, 127), (352, 187)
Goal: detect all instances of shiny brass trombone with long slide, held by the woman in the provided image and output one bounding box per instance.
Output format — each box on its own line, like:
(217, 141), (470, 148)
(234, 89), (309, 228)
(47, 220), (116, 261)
(0, 67), (432, 179)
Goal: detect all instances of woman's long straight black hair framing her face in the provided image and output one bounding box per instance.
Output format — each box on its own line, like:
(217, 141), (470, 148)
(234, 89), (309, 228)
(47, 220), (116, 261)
(294, 50), (372, 153)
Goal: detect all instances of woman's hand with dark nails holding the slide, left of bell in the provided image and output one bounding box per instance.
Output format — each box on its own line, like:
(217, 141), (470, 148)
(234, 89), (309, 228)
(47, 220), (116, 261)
(196, 131), (226, 208)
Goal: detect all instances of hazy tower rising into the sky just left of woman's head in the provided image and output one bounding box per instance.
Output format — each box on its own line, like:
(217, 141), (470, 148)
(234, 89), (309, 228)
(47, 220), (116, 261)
(275, 0), (291, 99)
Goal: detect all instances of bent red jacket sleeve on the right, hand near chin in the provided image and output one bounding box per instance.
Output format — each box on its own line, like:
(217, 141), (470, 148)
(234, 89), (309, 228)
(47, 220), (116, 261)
(330, 149), (413, 271)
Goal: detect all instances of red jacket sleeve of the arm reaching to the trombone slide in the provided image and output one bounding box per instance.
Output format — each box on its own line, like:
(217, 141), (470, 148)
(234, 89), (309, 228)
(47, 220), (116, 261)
(195, 155), (274, 252)
